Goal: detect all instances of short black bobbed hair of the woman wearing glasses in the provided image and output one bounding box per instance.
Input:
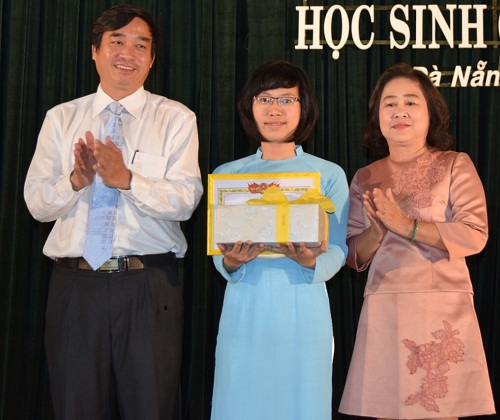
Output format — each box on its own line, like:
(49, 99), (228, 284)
(238, 60), (319, 144)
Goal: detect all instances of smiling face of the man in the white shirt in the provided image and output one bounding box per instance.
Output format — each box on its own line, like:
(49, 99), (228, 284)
(92, 17), (155, 100)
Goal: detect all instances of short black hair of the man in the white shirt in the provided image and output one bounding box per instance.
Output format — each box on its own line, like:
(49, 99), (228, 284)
(91, 4), (160, 57)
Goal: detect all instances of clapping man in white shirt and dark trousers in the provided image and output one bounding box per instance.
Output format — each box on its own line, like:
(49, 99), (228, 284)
(24, 5), (203, 420)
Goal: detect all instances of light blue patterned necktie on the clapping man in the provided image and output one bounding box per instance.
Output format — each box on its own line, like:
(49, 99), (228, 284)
(83, 102), (124, 270)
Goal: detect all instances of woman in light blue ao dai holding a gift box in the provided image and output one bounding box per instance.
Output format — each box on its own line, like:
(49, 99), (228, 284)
(212, 61), (349, 420)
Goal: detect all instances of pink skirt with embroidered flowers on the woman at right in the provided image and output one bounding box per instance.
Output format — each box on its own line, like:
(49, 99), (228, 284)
(339, 292), (495, 419)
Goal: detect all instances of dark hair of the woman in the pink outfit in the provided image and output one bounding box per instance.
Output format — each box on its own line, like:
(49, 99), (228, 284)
(363, 63), (453, 156)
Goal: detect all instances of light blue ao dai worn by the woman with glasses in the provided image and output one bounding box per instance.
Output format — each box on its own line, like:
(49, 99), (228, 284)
(212, 146), (349, 420)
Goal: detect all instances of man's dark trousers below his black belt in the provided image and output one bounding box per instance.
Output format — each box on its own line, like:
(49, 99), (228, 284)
(45, 264), (183, 420)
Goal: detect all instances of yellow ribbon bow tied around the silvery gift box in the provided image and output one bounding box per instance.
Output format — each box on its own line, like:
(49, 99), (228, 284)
(247, 185), (335, 243)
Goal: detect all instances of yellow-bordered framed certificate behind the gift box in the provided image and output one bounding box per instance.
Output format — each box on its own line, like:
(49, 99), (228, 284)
(207, 172), (320, 255)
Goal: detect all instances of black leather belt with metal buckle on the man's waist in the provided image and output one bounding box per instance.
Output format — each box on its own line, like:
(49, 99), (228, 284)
(55, 252), (177, 273)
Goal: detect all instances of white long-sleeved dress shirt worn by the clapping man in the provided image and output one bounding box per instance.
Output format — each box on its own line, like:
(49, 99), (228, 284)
(24, 86), (203, 258)
